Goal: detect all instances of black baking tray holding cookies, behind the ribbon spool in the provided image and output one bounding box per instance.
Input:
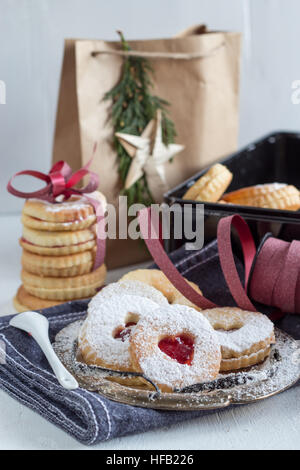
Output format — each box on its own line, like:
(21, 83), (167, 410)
(164, 132), (300, 251)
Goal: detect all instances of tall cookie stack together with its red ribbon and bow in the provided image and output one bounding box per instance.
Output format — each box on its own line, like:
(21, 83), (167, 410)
(7, 158), (106, 311)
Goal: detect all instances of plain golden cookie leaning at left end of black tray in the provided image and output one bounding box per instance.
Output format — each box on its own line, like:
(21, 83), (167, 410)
(183, 163), (233, 202)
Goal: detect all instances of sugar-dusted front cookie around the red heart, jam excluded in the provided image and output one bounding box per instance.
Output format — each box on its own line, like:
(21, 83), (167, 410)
(131, 305), (221, 389)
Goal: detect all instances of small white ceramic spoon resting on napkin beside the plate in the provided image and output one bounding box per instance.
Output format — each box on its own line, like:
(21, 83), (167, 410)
(9, 312), (78, 390)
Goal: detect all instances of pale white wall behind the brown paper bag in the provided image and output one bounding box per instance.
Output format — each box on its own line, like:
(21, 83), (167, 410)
(0, 0), (300, 213)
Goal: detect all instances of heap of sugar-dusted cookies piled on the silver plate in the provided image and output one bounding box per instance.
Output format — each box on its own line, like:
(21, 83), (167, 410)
(76, 270), (275, 393)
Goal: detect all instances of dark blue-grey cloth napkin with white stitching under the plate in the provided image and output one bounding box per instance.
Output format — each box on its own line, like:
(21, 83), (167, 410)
(0, 242), (300, 445)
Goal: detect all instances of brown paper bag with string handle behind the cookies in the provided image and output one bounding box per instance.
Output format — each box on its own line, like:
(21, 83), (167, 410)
(53, 26), (241, 268)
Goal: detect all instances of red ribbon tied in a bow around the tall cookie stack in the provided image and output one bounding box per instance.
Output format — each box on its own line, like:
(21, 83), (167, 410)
(7, 156), (106, 270)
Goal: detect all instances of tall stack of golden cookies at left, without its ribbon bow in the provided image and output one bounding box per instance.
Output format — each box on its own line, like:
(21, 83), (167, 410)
(14, 192), (106, 312)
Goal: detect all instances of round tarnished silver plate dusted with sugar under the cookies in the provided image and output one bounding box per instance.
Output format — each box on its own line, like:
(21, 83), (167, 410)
(53, 320), (300, 411)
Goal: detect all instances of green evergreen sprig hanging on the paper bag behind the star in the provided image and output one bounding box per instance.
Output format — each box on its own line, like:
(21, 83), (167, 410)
(104, 31), (176, 206)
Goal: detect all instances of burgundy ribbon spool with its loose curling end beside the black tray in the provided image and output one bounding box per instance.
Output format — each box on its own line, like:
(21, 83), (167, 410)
(139, 209), (300, 319)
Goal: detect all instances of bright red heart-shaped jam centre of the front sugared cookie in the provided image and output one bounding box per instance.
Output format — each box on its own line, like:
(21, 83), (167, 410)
(158, 334), (194, 366)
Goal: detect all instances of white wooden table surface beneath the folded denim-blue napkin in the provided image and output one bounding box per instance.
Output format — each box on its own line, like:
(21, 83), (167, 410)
(0, 216), (300, 450)
